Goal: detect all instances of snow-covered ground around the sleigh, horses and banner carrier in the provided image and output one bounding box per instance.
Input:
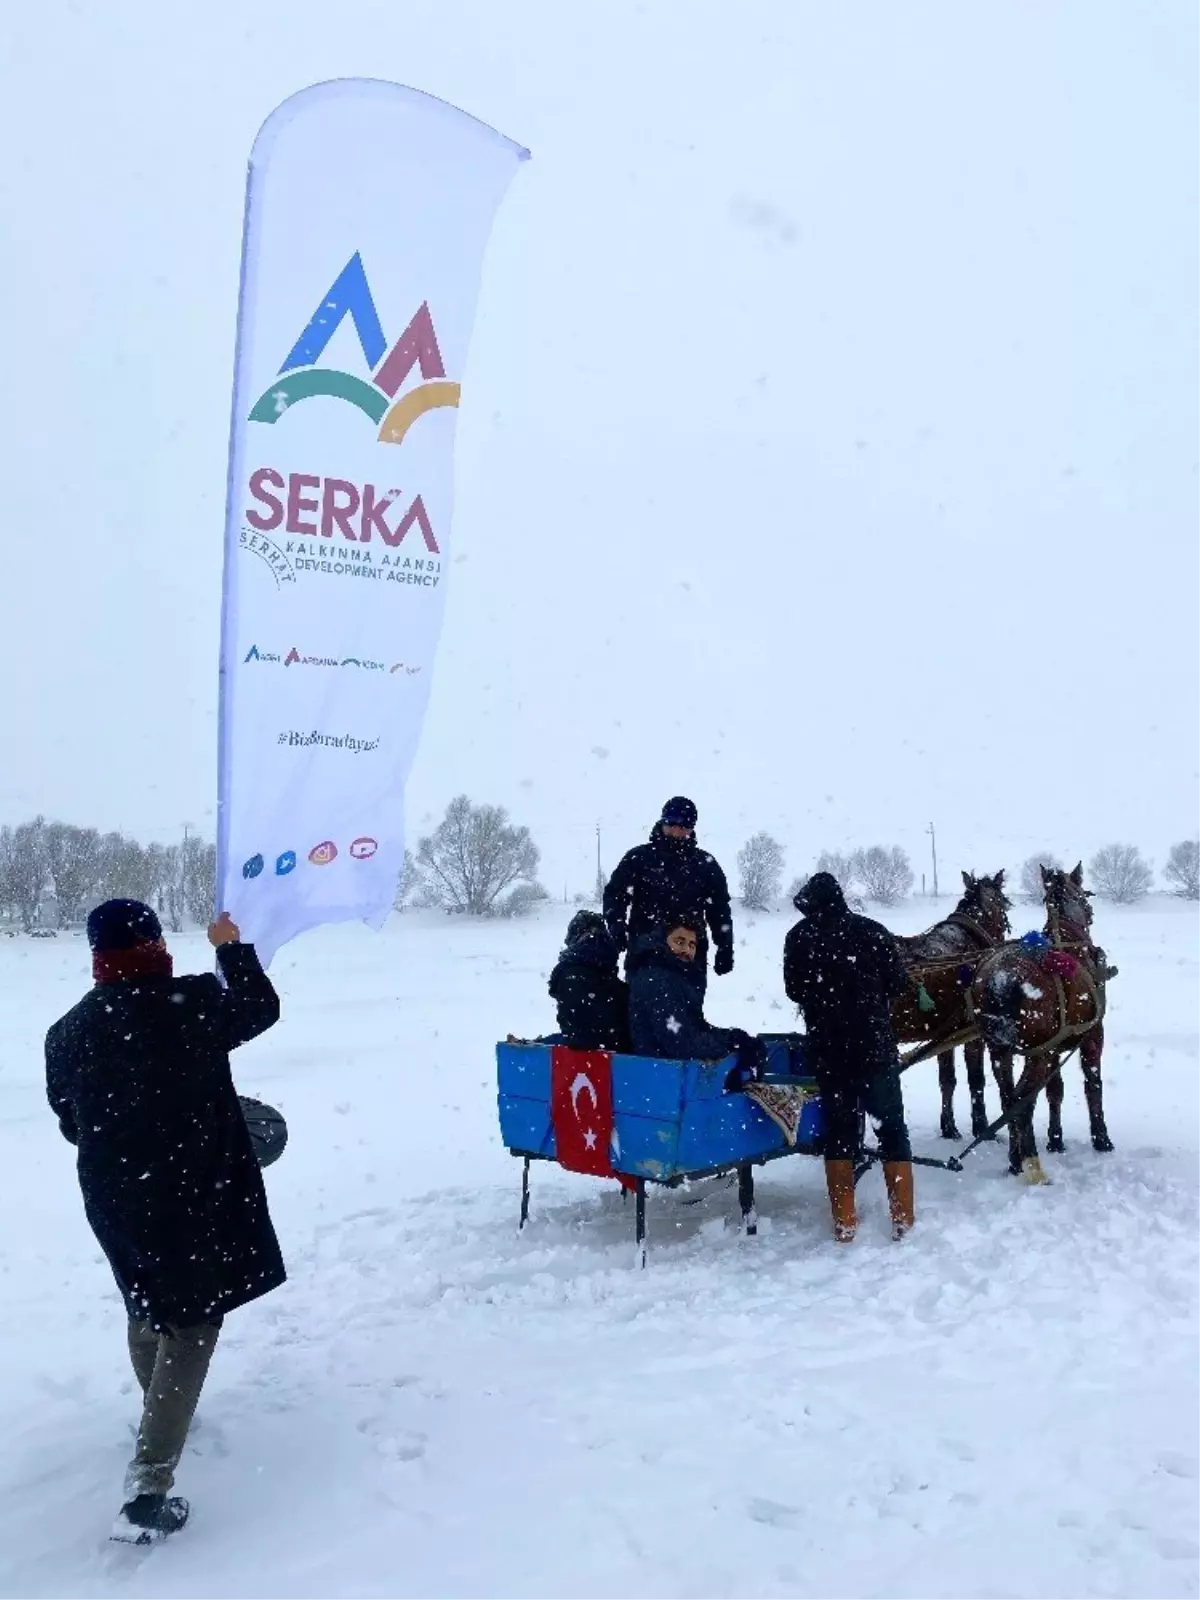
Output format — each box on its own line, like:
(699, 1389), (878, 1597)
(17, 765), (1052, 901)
(0, 901), (1200, 1600)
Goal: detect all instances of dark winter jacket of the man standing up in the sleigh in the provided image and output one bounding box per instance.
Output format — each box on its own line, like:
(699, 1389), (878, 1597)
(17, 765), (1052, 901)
(605, 822), (733, 966)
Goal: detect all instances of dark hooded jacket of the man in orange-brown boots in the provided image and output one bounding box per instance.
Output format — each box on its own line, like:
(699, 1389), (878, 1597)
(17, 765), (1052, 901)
(784, 893), (909, 1080)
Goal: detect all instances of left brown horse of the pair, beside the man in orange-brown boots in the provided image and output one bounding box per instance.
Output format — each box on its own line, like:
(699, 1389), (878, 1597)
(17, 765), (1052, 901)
(893, 870), (1011, 1139)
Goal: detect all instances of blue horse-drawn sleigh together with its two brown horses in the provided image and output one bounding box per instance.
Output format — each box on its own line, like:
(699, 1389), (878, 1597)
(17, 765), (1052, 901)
(496, 867), (1115, 1264)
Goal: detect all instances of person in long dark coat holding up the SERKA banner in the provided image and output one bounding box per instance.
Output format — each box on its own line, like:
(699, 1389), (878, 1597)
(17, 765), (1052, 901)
(46, 901), (285, 1544)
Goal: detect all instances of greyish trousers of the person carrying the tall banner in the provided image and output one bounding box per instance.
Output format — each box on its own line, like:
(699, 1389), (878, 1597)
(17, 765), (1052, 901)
(125, 1318), (221, 1501)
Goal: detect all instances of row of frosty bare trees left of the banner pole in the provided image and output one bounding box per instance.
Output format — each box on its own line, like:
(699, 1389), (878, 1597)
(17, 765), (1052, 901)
(0, 816), (216, 933)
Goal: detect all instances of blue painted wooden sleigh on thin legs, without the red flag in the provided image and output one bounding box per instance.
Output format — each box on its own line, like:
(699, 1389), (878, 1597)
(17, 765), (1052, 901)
(496, 1038), (822, 1261)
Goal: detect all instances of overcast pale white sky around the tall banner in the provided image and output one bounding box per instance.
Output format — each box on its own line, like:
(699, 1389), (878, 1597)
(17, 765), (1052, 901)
(0, 0), (1200, 891)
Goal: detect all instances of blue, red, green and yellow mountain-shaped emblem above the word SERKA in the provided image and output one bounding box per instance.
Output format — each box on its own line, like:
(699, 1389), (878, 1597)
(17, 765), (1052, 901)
(250, 251), (461, 445)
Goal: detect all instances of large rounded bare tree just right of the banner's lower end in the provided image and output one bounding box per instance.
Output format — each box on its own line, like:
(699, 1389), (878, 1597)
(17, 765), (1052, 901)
(416, 795), (541, 917)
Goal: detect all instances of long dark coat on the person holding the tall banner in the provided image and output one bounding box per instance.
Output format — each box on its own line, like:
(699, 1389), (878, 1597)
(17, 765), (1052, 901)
(46, 944), (286, 1328)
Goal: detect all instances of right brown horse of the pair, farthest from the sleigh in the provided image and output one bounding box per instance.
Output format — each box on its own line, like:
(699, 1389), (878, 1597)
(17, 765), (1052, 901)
(971, 862), (1115, 1184)
